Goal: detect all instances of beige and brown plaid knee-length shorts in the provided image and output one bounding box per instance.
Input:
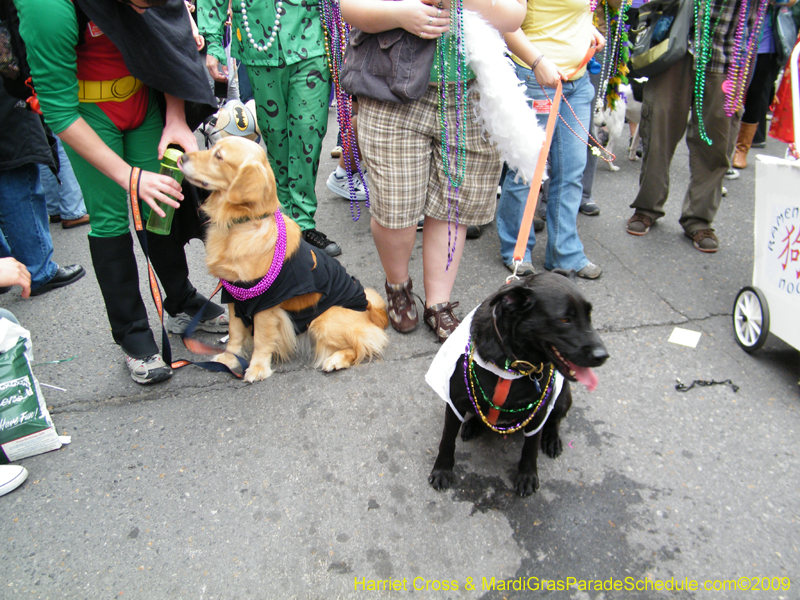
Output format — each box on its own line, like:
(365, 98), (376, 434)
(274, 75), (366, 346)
(358, 84), (503, 229)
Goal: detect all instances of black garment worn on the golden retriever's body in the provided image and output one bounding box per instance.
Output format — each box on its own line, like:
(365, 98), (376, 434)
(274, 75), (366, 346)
(222, 240), (367, 334)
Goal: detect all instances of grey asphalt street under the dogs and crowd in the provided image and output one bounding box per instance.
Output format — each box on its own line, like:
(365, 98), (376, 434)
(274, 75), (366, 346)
(0, 111), (800, 600)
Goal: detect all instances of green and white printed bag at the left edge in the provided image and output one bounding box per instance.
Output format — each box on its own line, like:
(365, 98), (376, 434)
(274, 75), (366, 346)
(0, 319), (69, 464)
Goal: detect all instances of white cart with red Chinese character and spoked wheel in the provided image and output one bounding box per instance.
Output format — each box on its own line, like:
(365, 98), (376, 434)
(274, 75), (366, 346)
(733, 44), (800, 380)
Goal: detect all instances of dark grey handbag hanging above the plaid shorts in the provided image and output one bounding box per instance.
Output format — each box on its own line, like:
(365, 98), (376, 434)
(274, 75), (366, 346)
(339, 28), (436, 104)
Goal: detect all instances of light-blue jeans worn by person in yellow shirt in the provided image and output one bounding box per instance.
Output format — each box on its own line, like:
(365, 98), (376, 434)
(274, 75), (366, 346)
(497, 65), (594, 271)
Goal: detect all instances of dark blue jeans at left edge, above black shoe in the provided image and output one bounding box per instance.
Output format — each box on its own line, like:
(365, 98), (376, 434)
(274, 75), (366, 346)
(0, 164), (58, 290)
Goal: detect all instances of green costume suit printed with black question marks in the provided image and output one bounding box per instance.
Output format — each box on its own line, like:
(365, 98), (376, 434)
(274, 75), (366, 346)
(197, 0), (331, 231)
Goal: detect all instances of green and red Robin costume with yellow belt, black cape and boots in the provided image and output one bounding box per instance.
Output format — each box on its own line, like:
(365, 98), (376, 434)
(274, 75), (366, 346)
(16, 0), (222, 358)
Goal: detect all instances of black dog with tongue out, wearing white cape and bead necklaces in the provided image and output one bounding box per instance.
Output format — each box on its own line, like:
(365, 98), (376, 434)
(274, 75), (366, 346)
(426, 270), (608, 497)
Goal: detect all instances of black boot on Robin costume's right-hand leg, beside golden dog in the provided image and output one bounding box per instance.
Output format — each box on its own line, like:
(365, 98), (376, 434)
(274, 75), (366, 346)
(147, 231), (224, 320)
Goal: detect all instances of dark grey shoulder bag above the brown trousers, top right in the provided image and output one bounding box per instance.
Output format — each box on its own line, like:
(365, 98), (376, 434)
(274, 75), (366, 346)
(631, 0), (694, 77)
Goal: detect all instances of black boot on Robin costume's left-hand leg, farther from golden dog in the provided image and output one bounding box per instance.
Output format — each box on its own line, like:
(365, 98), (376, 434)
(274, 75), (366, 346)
(89, 233), (158, 358)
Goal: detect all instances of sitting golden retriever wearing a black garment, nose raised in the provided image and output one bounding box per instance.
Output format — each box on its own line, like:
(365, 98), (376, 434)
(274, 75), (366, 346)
(180, 137), (389, 382)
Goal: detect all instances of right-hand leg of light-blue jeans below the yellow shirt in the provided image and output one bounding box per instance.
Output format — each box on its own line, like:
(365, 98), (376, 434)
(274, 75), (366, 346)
(544, 75), (594, 272)
